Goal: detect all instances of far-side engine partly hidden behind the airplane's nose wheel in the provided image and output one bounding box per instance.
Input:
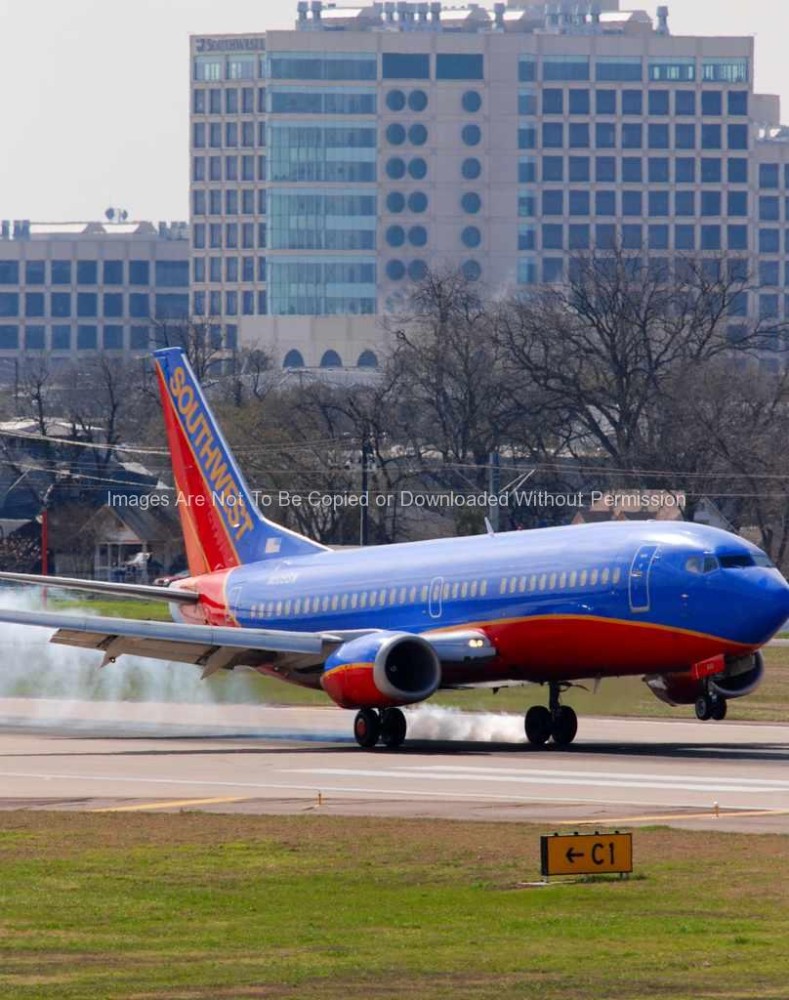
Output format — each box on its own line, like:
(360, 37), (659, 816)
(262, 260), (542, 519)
(644, 652), (764, 705)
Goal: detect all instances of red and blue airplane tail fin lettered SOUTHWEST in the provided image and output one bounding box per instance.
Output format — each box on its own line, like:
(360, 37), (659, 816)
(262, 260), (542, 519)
(154, 347), (325, 576)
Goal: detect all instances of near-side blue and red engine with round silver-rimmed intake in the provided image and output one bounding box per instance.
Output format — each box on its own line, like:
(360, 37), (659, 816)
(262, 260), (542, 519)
(321, 632), (441, 708)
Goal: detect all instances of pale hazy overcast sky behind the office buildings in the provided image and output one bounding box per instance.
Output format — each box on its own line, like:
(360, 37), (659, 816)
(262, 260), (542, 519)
(0, 0), (789, 221)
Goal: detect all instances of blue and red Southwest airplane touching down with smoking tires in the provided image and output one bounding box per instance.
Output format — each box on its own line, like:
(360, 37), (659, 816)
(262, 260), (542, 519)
(0, 348), (789, 749)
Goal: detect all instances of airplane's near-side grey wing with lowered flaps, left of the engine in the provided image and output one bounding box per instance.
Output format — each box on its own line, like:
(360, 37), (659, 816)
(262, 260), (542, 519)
(0, 608), (348, 677)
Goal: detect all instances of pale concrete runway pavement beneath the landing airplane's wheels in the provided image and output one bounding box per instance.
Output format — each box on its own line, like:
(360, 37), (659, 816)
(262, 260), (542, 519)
(0, 699), (789, 832)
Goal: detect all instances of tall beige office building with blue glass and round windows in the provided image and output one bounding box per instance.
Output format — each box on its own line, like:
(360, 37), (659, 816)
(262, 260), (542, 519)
(191, 0), (789, 367)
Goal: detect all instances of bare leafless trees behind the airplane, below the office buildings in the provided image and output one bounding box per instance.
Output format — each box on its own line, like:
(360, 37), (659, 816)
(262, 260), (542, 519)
(3, 251), (789, 564)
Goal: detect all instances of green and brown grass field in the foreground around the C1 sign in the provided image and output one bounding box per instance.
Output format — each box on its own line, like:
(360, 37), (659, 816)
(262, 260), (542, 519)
(0, 812), (789, 1000)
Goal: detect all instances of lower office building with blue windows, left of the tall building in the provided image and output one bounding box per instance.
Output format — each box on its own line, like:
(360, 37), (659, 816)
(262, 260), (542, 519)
(0, 221), (189, 374)
